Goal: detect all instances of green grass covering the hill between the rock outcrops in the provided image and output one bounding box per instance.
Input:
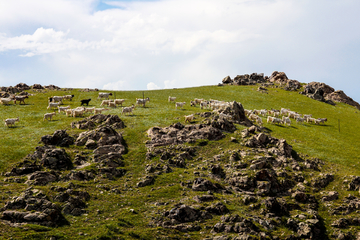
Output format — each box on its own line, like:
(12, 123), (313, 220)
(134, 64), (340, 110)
(0, 83), (360, 239)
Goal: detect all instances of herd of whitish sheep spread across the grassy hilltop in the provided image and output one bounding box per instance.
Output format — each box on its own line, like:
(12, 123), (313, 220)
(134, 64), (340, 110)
(0, 89), (327, 127)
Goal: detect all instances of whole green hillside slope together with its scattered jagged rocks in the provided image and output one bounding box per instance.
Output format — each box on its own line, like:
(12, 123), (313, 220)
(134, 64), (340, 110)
(0, 83), (360, 239)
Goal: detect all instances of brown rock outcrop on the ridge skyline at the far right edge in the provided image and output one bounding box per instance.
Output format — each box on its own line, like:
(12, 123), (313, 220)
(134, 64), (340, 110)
(300, 82), (360, 109)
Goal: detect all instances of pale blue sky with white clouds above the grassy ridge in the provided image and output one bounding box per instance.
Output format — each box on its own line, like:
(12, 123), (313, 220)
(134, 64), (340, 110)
(0, 0), (360, 102)
